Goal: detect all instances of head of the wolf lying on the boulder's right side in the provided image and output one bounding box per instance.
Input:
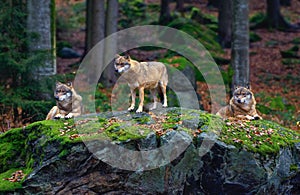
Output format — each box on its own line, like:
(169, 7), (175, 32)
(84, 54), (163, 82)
(233, 87), (254, 105)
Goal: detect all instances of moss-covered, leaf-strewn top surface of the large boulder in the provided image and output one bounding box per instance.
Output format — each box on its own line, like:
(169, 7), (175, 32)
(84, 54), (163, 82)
(0, 108), (300, 192)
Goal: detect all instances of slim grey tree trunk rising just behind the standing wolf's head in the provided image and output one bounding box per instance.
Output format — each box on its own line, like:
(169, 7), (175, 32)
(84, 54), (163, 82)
(100, 0), (119, 87)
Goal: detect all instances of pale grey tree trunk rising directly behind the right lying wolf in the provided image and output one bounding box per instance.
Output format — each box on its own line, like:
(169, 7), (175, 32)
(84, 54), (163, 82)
(231, 0), (250, 86)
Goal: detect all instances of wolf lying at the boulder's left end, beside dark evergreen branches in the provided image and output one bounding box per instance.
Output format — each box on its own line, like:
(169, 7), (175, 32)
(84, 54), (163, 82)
(46, 82), (82, 120)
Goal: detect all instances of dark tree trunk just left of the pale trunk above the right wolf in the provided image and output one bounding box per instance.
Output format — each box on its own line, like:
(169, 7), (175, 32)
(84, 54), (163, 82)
(218, 0), (232, 48)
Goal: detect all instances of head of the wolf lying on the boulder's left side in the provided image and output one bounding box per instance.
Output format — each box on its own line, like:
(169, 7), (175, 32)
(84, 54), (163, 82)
(54, 82), (73, 101)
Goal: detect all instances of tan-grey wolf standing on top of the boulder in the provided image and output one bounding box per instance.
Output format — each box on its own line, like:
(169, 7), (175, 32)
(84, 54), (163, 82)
(114, 55), (168, 113)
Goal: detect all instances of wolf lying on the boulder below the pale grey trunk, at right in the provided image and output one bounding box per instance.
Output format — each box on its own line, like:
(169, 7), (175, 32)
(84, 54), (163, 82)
(217, 86), (262, 120)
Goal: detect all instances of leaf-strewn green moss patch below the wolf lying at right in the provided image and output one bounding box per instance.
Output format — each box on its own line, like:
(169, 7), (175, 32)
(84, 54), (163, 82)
(220, 120), (300, 155)
